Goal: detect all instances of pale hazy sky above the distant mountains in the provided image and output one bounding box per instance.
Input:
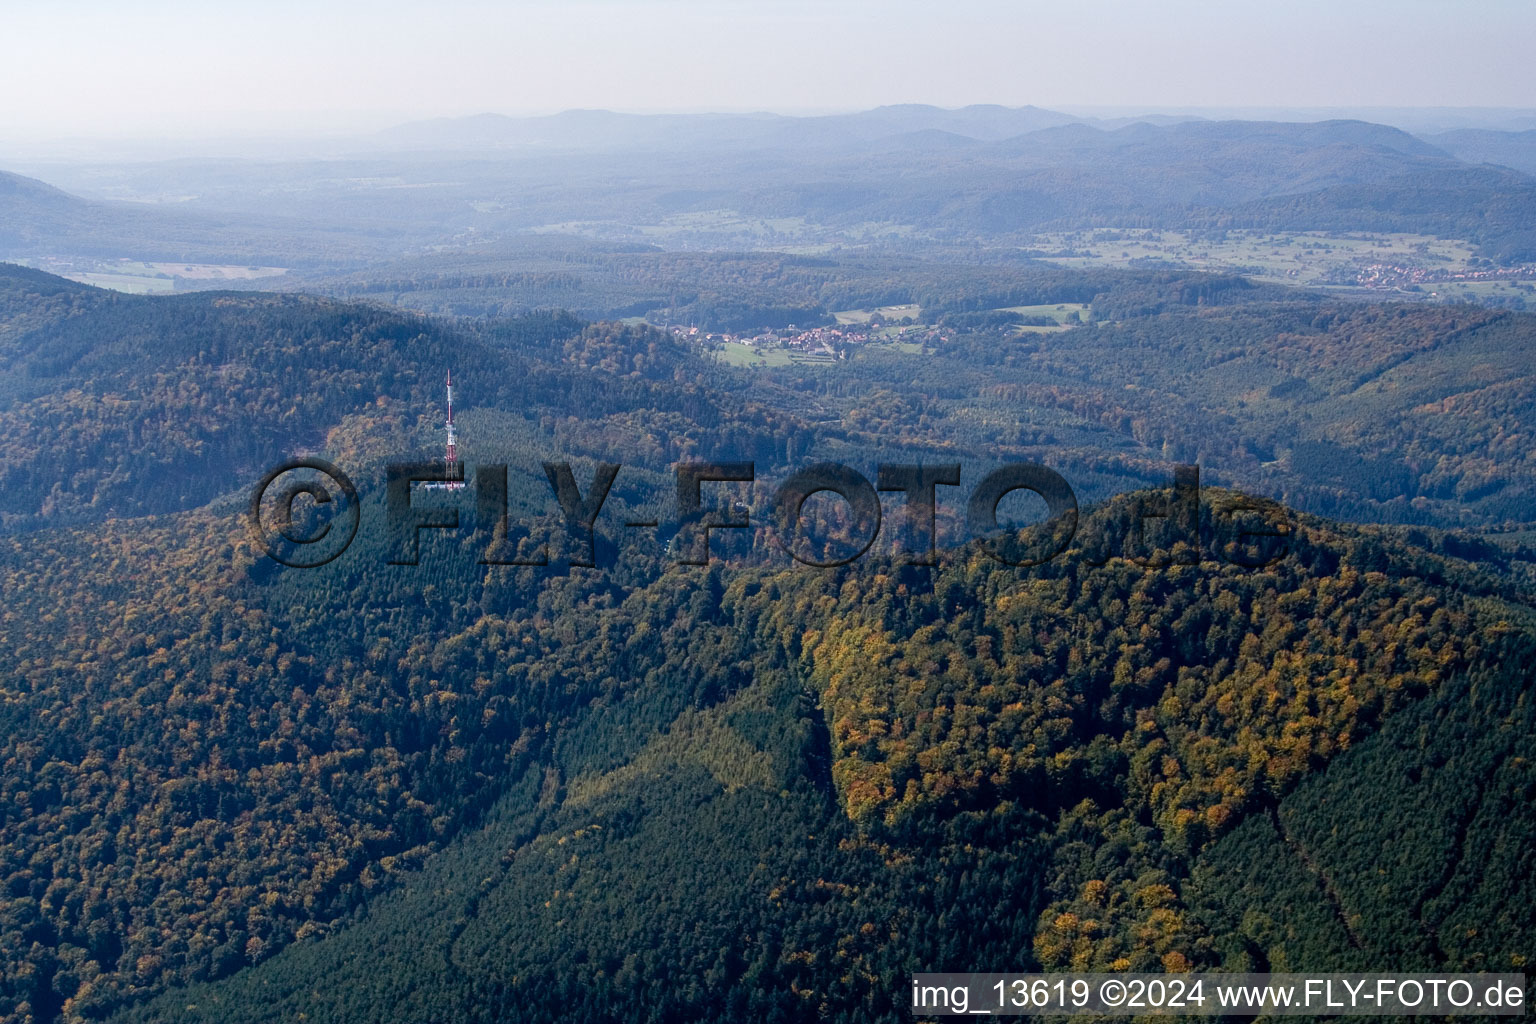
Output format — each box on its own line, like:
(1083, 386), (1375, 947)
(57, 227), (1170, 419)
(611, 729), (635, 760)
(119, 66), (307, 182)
(0, 0), (1536, 138)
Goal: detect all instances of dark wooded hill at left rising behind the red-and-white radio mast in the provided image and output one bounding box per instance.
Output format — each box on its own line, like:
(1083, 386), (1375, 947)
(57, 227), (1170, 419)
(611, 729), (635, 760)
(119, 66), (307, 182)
(0, 267), (734, 528)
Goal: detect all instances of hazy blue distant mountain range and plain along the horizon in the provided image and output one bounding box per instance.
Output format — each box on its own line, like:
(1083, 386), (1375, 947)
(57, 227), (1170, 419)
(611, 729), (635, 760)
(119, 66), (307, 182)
(9, 104), (1536, 267)
